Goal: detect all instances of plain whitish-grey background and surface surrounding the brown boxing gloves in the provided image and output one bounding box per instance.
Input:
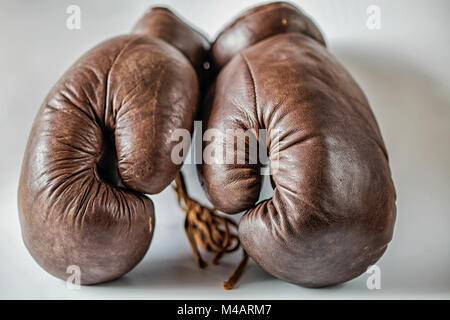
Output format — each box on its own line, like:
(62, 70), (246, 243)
(0, 0), (450, 299)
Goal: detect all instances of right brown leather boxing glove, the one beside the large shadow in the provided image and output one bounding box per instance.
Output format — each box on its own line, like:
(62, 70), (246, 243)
(199, 3), (396, 287)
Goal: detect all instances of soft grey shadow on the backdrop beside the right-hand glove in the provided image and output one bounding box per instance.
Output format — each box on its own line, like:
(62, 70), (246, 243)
(332, 45), (450, 294)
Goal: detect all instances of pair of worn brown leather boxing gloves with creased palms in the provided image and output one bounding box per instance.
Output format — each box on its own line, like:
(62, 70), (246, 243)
(18, 2), (396, 287)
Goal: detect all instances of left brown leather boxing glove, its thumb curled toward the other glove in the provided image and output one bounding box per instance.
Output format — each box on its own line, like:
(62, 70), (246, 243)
(18, 8), (209, 284)
